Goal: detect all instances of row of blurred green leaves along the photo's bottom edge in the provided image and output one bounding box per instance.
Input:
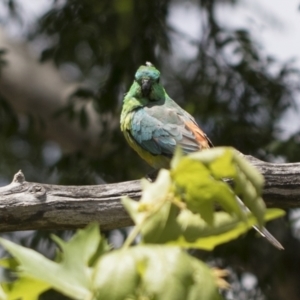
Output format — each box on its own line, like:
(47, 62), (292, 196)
(1, 224), (221, 300)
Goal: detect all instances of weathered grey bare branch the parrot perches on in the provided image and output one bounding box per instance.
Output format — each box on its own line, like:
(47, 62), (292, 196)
(0, 156), (300, 231)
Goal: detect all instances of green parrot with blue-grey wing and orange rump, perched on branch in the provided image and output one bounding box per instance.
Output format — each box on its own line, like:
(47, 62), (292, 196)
(120, 62), (284, 250)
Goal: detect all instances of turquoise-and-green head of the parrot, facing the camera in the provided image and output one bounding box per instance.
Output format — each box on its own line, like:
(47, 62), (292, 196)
(135, 62), (160, 97)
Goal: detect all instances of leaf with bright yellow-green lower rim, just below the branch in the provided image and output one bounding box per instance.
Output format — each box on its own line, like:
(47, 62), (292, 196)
(141, 204), (284, 251)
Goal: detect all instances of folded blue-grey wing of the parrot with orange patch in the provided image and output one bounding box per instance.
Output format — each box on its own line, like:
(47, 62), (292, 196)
(130, 105), (210, 156)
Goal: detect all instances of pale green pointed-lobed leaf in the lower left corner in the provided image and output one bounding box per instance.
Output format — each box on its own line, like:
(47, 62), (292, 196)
(0, 224), (107, 299)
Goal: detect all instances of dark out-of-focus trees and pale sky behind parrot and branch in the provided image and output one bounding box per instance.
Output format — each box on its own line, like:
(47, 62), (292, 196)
(0, 0), (300, 300)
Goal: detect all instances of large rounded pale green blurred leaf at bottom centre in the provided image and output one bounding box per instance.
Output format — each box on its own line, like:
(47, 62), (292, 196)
(93, 246), (221, 300)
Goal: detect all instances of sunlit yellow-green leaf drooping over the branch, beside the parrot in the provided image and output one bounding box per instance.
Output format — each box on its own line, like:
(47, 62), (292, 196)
(175, 147), (266, 227)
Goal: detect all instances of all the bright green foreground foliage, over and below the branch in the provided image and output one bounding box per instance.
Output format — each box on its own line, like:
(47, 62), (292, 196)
(0, 148), (283, 300)
